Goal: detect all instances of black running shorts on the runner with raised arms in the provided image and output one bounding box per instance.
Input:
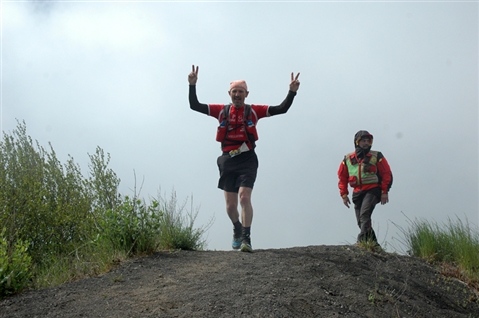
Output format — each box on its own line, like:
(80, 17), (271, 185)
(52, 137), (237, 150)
(217, 150), (258, 193)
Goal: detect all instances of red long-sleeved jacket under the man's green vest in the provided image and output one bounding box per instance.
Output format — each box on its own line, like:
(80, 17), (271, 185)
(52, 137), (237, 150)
(338, 152), (392, 196)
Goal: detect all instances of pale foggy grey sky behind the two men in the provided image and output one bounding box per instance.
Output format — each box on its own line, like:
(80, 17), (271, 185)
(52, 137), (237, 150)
(1, 1), (479, 250)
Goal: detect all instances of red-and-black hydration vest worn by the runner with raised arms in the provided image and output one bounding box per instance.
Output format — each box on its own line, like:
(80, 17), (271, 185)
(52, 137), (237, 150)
(216, 104), (258, 149)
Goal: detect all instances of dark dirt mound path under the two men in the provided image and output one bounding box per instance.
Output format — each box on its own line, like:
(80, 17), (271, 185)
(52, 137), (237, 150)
(0, 246), (479, 318)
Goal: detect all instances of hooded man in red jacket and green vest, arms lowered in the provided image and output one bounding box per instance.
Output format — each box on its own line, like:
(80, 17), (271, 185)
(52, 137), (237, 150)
(338, 130), (393, 246)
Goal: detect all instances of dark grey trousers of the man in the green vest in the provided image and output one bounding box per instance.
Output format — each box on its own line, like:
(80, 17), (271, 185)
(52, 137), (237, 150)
(353, 188), (381, 242)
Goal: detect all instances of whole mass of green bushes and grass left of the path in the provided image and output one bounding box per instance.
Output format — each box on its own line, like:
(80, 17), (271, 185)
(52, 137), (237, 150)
(0, 122), (210, 296)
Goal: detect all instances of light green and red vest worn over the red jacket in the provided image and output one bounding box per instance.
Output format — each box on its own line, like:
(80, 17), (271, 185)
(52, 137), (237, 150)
(346, 150), (379, 187)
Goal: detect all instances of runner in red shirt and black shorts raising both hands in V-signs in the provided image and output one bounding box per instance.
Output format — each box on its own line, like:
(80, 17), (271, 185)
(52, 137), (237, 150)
(188, 65), (300, 252)
